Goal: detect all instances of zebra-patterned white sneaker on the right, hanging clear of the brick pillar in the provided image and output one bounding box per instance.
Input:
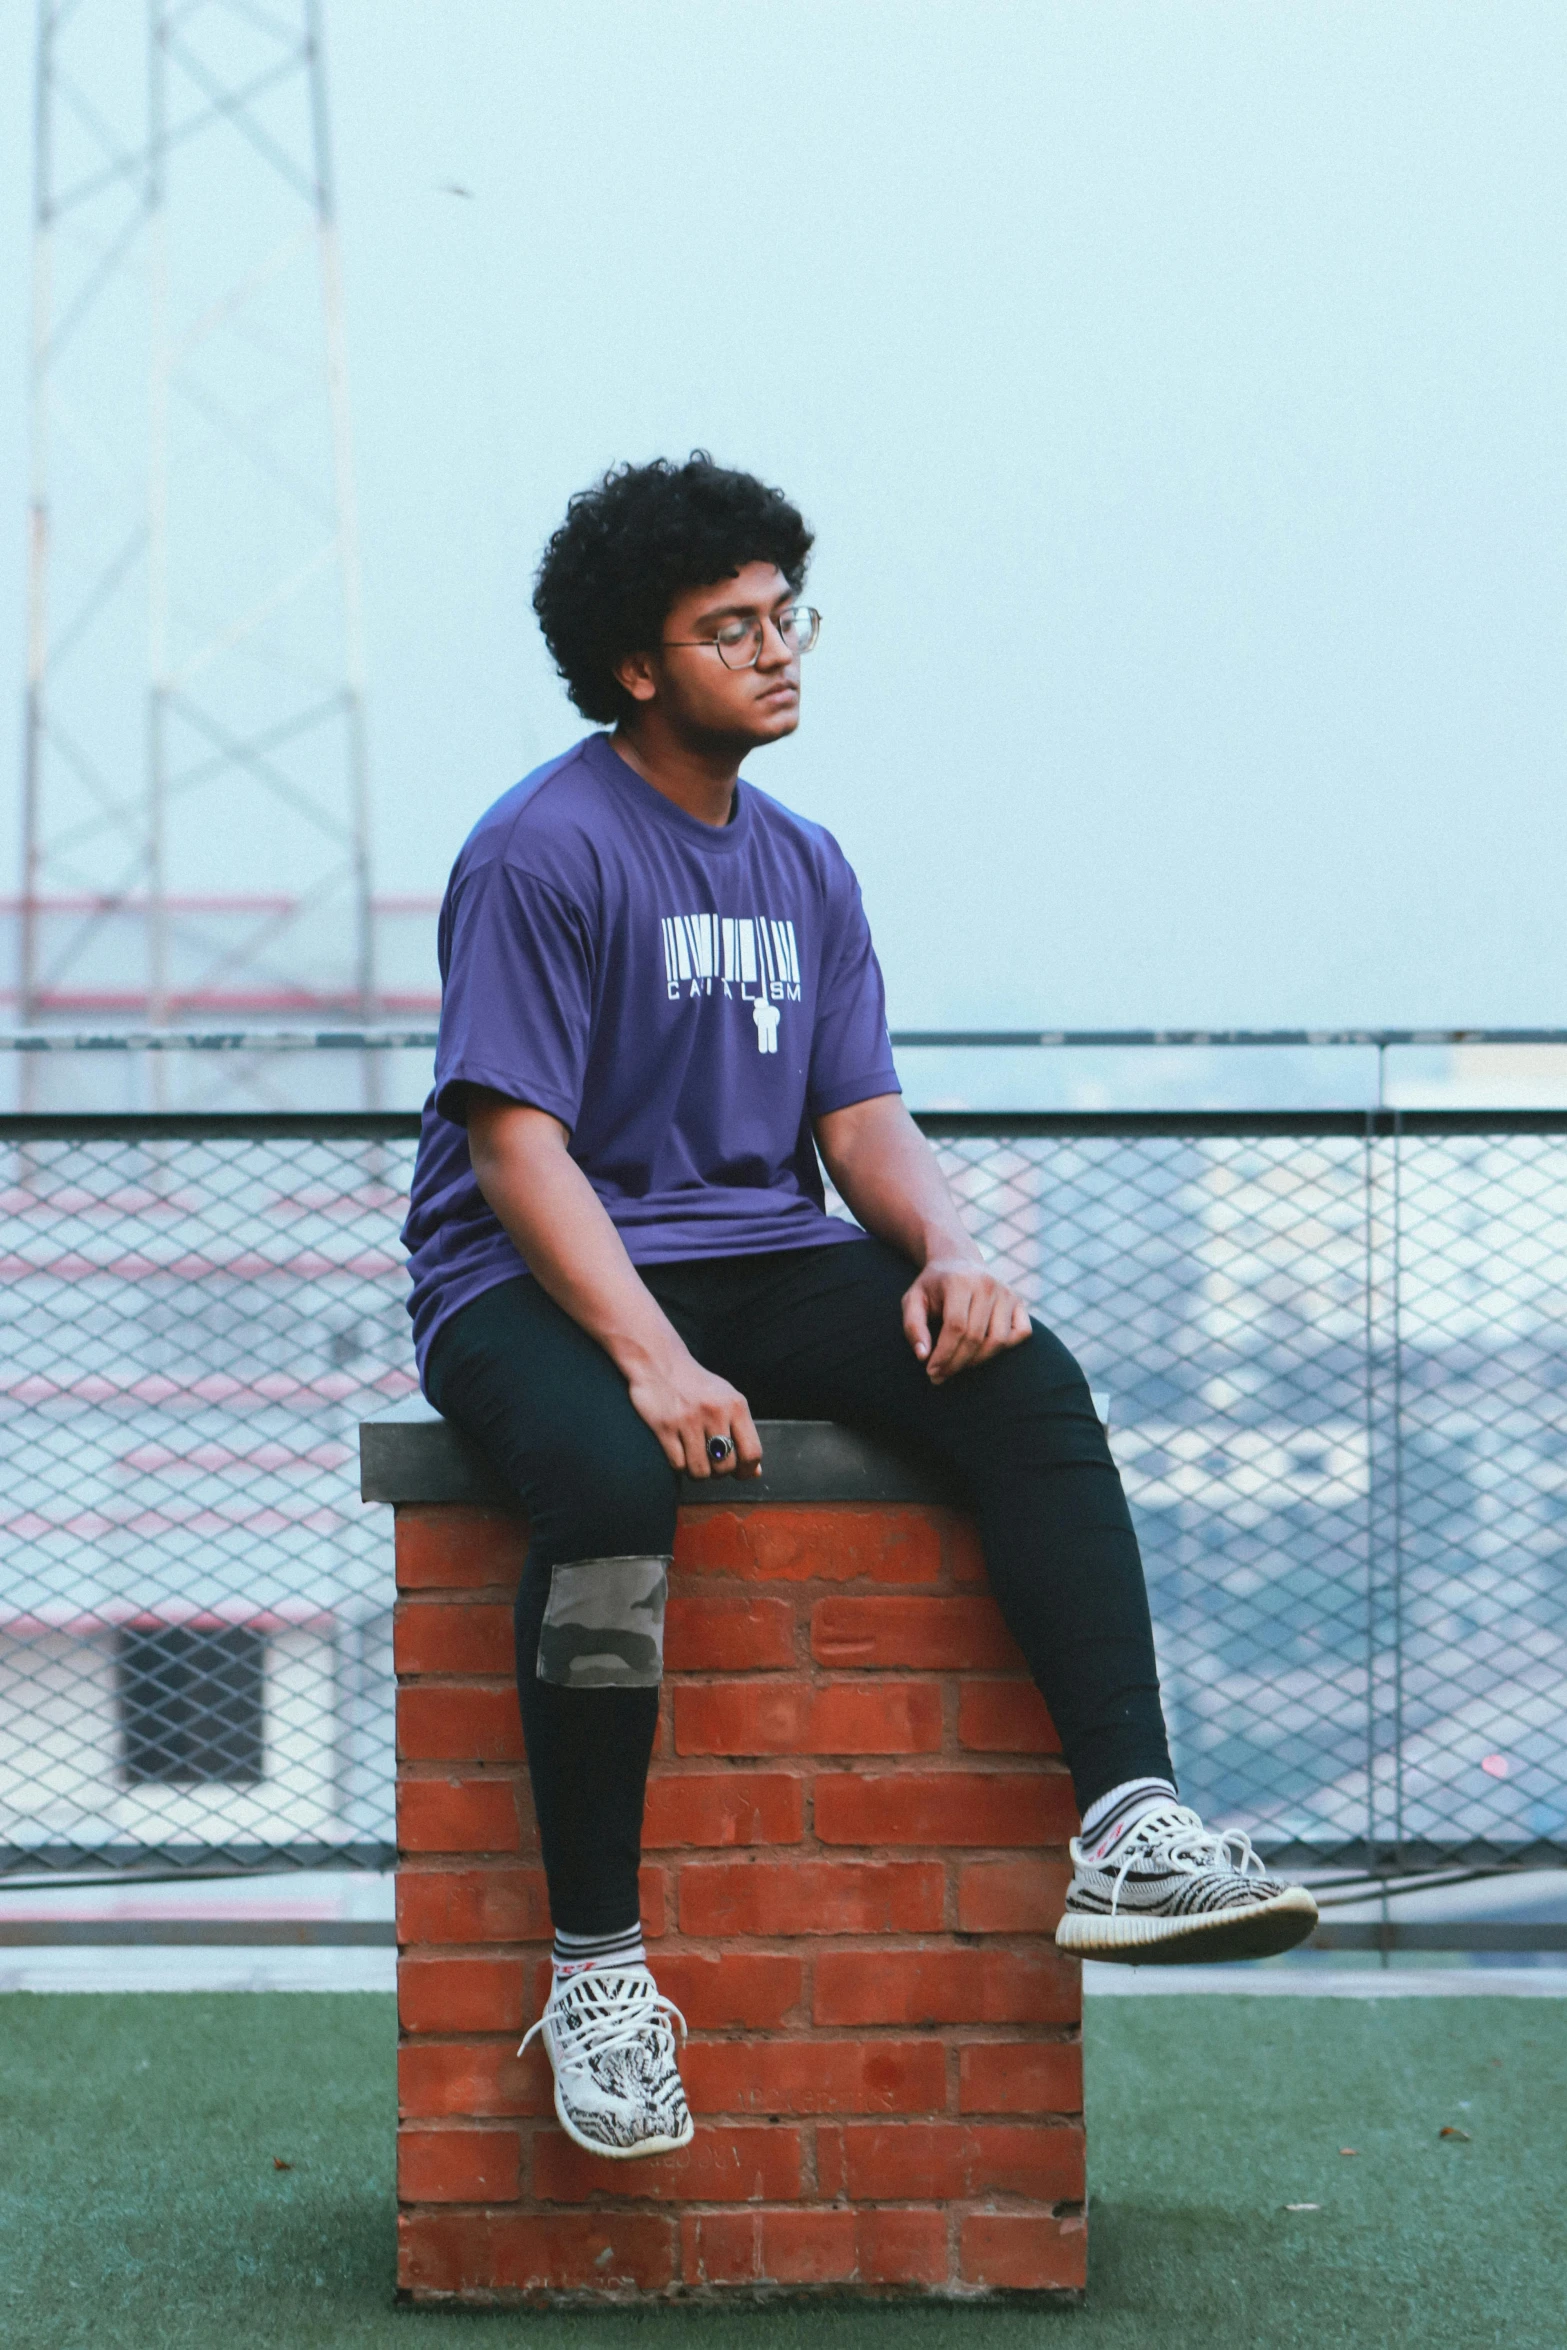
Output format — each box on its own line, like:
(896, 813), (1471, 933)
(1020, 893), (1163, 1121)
(1055, 1802), (1316, 1967)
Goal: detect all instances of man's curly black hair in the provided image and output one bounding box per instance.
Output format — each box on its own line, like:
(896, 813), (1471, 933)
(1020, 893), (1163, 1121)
(533, 449), (811, 726)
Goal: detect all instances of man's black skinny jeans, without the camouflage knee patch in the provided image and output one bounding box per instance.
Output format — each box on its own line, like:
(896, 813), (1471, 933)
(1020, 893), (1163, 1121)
(425, 1241), (1172, 1934)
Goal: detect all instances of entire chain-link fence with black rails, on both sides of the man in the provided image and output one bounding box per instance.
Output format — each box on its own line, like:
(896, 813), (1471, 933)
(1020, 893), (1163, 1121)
(0, 1114), (1567, 1873)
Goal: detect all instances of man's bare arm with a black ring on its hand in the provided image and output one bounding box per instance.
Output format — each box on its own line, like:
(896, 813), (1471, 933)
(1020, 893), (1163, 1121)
(468, 1086), (761, 1478)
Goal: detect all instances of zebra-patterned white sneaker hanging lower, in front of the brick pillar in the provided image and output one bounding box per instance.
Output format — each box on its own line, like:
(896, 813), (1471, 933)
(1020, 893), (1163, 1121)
(517, 1967), (693, 2162)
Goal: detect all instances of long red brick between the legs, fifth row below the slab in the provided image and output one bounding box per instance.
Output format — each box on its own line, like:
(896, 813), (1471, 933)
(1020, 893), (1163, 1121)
(679, 1859), (947, 1934)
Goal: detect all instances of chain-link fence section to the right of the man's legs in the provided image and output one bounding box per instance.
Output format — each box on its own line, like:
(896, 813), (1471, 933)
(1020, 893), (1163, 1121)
(926, 1114), (1567, 1871)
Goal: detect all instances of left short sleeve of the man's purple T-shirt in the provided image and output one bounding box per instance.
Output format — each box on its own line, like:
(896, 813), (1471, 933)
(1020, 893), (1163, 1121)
(435, 862), (594, 1128)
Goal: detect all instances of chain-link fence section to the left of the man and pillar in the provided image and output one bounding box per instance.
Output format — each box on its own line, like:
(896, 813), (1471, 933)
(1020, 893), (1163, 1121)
(0, 1116), (413, 1871)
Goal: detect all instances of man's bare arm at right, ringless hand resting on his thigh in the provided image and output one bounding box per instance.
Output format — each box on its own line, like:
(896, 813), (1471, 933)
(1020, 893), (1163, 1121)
(815, 1093), (1031, 1387)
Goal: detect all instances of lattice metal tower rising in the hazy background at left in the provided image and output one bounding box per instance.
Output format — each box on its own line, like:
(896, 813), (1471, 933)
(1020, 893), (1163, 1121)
(19, 0), (376, 1025)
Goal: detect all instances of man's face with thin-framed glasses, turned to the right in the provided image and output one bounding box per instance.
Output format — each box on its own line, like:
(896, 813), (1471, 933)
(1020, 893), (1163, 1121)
(618, 564), (799, 747)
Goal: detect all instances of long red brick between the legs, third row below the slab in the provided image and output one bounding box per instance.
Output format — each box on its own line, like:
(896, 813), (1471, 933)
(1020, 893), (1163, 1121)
(674, 1680), (942, 1755)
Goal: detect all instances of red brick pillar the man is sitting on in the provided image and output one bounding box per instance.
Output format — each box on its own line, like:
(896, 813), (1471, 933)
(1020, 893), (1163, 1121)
(380, 1422), (1088, 2303)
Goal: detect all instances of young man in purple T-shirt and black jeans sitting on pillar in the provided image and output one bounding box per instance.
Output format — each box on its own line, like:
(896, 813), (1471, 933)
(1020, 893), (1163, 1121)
(404, 454), (1316, 2155)
